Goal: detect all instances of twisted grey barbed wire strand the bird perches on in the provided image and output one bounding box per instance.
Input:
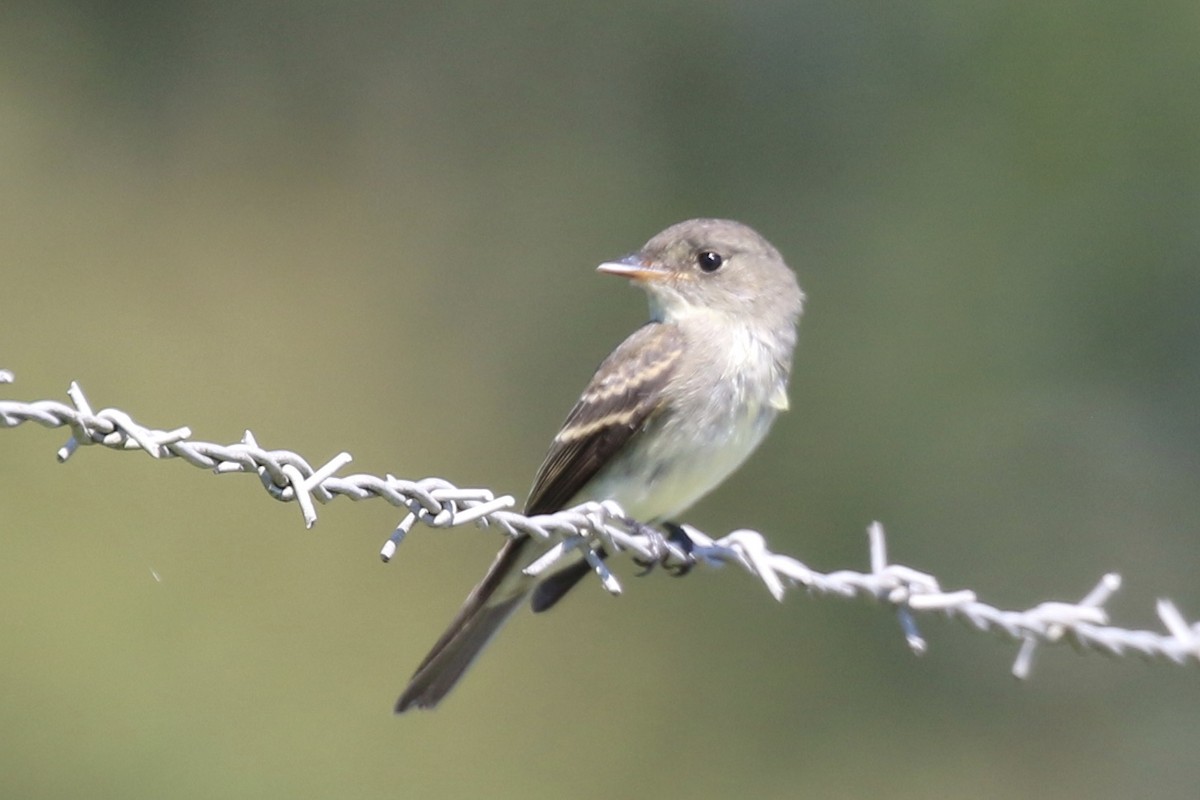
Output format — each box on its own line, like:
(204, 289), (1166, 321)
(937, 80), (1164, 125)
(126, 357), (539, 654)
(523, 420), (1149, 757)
(0, 379), (1200, 679)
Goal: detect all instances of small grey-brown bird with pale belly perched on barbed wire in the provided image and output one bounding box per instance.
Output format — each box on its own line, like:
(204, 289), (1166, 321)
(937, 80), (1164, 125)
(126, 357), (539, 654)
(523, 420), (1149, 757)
(395, 218), (805, 714)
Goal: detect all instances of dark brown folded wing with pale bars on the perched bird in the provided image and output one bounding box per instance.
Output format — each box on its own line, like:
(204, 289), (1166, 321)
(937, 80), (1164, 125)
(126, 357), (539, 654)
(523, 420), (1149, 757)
(526, 323), (683, 515)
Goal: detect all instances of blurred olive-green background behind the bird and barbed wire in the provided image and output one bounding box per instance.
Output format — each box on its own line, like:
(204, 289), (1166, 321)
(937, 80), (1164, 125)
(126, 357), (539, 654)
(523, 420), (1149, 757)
(0, 0), (1200, 799)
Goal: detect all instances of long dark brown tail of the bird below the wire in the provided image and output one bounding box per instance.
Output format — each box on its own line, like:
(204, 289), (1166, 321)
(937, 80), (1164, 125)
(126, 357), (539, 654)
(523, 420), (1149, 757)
(396, 536), (533, 714)
